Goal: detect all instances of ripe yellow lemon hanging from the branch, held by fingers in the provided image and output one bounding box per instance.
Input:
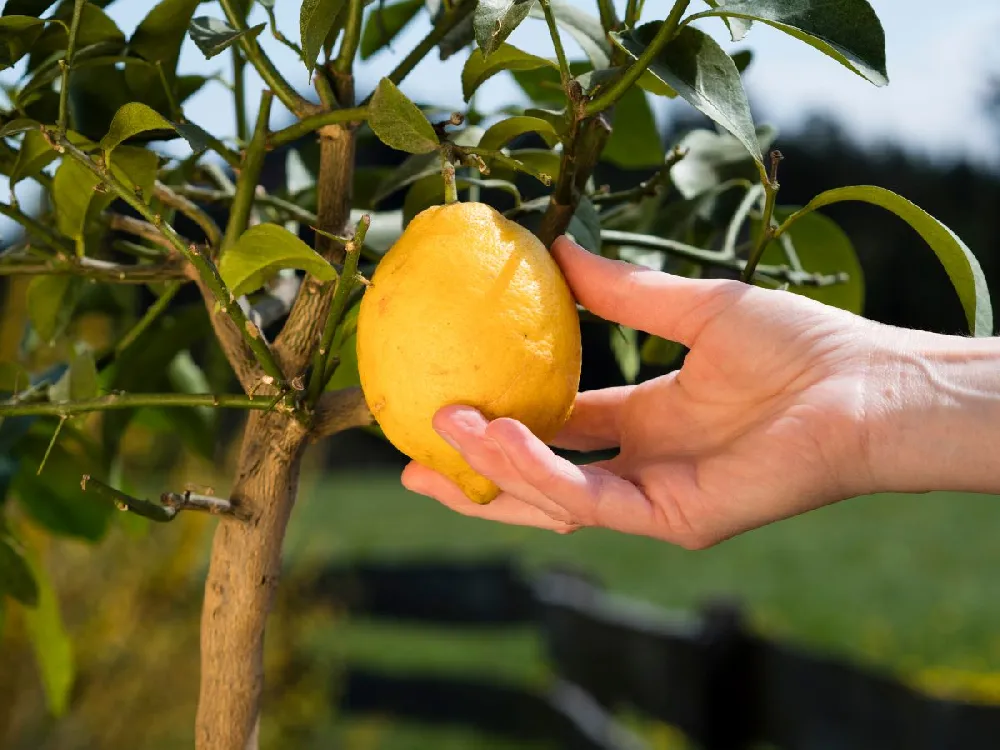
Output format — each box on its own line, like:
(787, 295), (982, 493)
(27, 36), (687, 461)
(357, 203), (581, 503)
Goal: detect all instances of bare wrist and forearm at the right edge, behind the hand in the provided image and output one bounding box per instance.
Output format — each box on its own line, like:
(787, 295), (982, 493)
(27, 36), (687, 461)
(867, 331), (1000, 494)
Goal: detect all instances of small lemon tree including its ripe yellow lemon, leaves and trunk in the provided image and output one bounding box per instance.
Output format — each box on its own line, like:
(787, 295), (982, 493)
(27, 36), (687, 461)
(0, 0), (993, 750)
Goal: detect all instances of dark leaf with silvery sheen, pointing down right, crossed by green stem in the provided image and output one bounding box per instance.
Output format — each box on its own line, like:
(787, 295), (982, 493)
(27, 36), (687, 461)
(611, 23), (764, 169)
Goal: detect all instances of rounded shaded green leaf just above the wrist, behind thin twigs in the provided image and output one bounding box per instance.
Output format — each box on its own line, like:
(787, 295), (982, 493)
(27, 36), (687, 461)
(751, 207), (865, 315)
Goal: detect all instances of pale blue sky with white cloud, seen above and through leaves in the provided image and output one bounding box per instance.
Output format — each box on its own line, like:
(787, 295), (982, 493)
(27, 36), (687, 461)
(0, 0), (1000, 241)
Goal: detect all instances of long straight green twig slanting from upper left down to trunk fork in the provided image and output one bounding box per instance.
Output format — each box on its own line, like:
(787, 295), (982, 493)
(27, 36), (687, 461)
(56, 131), (285, 382)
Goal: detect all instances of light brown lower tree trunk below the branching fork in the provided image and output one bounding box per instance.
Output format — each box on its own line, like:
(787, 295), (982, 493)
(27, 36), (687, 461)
(195, 412), (307, 750)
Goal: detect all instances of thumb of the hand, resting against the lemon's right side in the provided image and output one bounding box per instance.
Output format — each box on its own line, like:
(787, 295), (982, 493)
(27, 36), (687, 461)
(552, 237), (750, 346)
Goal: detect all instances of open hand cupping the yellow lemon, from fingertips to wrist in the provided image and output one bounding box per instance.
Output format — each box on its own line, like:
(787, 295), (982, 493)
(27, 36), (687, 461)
(402, 238), (992, 549)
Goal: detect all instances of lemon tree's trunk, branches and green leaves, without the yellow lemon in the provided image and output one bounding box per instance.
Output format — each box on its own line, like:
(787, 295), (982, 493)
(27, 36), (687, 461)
(0, 0), (993, 748)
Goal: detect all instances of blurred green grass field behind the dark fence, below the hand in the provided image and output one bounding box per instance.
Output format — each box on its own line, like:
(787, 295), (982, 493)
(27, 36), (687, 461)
(268, 474), (1000, 750)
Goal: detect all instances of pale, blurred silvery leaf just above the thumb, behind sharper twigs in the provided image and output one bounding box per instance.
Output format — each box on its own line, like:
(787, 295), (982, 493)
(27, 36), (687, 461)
(670, 125), (777, 199)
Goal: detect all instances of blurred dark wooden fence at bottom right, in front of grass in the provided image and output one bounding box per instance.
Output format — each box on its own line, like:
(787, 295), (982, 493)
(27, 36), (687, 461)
(312, 562), (1000, 750)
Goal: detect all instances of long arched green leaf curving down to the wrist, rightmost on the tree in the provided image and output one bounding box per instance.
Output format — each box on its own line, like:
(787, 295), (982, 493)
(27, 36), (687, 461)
(782, 185), (993, 336)
